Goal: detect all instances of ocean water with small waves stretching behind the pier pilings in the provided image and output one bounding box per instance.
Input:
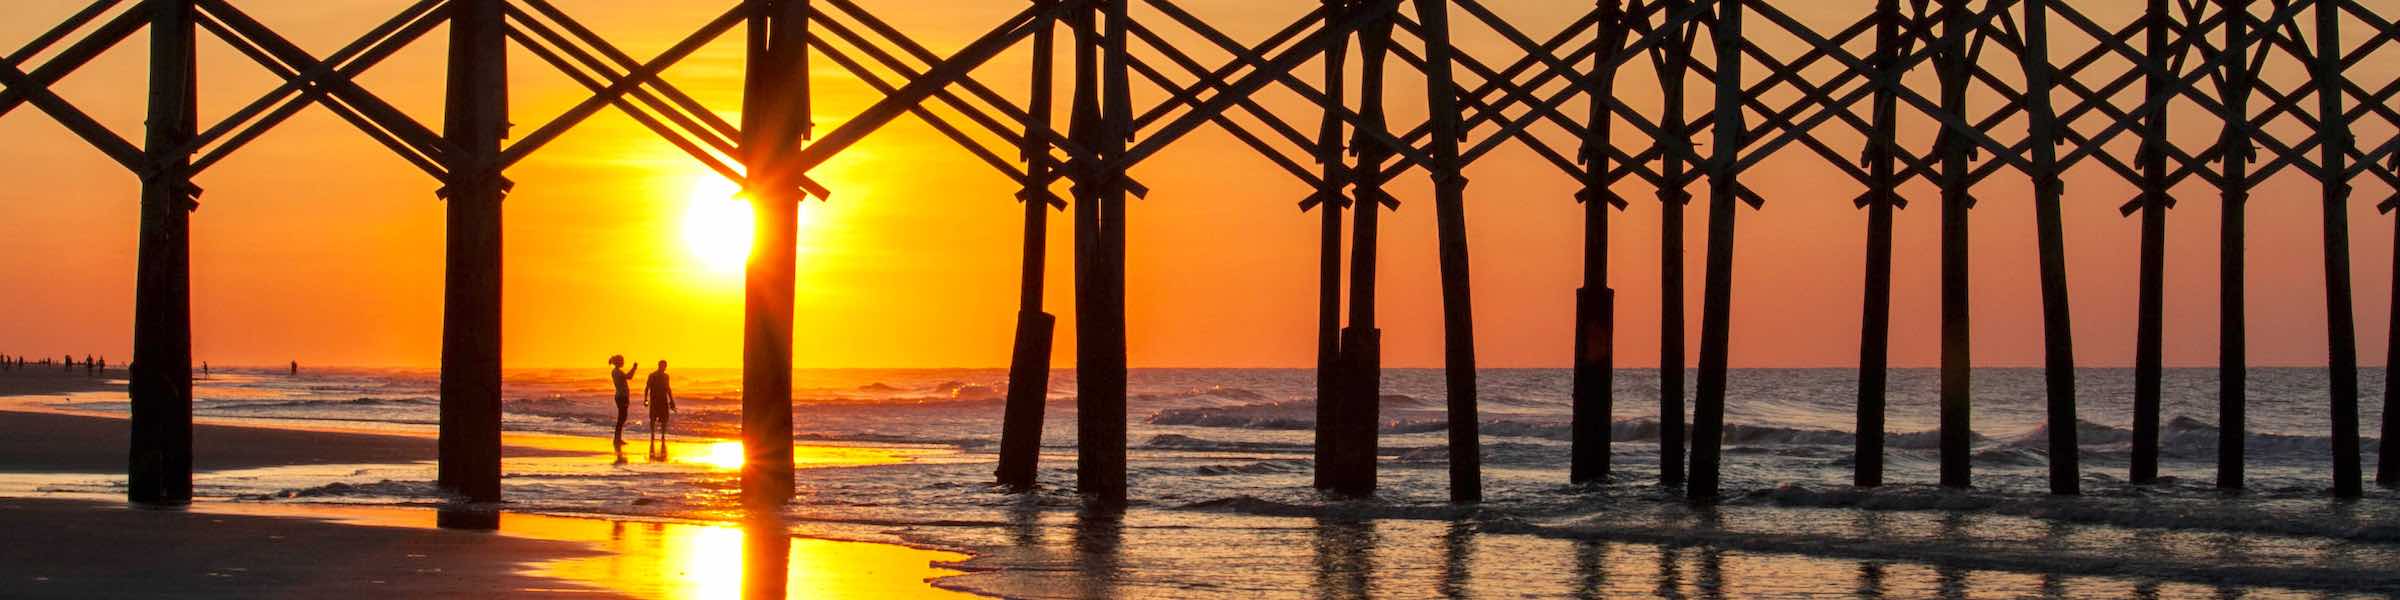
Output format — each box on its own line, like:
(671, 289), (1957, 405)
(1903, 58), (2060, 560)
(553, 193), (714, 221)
(23, 367), (2400, 598)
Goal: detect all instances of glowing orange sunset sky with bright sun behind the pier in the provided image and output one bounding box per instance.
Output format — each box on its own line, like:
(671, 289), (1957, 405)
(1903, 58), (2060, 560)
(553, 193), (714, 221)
(0, 0), (2400, 367)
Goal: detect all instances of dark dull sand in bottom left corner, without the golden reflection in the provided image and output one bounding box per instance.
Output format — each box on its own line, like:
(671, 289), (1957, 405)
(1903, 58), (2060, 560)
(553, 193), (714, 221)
(0, 499), (622, 598)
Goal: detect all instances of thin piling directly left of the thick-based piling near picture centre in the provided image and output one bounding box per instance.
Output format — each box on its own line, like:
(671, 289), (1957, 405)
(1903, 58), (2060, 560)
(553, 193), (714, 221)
(1301, 0), (1349, 490)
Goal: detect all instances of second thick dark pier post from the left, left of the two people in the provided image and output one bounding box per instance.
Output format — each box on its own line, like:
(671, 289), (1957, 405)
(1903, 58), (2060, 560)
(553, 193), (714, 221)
(439, 0), (509, 502)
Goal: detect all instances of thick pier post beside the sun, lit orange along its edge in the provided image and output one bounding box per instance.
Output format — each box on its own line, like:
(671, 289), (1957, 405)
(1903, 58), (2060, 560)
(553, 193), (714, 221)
(742, 0), (811, 506)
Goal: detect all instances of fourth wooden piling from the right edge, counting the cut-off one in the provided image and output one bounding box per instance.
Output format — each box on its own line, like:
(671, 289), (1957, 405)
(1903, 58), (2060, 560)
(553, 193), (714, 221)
(2126, 0), (2174, 485)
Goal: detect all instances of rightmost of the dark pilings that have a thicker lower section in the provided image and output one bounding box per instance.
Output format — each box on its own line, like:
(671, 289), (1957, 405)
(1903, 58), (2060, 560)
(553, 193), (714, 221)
(1567, 0), (1627, 482)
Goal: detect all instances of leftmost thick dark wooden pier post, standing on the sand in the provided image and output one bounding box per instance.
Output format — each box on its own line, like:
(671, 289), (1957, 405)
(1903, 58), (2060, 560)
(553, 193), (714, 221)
(125, 0), (199, 504)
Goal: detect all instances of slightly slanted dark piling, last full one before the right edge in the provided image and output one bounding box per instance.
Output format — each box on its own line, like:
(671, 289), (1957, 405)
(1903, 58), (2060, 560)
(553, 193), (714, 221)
(2309, 2), (2366, 497)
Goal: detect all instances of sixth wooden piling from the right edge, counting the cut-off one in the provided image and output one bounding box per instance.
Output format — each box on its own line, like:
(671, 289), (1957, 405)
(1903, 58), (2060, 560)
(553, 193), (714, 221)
(1934, 0), (1975, 487)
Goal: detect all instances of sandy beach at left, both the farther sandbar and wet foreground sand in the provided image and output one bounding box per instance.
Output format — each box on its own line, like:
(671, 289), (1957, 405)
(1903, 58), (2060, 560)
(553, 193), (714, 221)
(0, 372), (967, 598)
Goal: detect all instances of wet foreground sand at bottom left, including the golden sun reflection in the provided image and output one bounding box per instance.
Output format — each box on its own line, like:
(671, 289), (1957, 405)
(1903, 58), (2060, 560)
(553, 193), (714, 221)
(0, 499), (972, 598)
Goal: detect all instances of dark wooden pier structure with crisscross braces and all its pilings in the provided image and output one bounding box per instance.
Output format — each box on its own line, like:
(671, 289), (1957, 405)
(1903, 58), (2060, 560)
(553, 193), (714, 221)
(0, 0), (2400, 504)
